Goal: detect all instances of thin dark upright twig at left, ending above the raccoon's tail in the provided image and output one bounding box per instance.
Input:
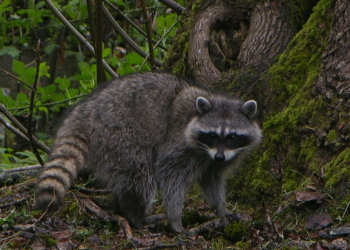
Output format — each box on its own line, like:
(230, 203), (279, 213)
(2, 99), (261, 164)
(27, 43), (44, 166)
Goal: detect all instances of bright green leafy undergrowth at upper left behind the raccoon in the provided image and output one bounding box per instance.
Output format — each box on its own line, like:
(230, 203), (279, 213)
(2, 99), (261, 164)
(0, 0), (176, 167)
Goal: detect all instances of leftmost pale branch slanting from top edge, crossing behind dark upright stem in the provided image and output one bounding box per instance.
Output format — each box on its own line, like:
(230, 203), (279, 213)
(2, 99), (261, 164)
(45, 0), (118, 78)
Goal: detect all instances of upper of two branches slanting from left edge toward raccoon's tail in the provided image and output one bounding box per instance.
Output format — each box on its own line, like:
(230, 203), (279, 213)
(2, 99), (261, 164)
(0, 103), (50, 154)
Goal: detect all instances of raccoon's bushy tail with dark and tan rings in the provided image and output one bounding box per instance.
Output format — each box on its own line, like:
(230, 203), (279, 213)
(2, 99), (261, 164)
(34, 135), (88, 212)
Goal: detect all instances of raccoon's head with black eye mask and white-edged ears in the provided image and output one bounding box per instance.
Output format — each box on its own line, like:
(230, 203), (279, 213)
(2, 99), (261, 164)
(185, 96), (262, 161)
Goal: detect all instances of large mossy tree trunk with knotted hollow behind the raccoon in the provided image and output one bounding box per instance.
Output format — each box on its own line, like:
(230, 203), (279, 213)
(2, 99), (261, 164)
(165, 0), (350, 223)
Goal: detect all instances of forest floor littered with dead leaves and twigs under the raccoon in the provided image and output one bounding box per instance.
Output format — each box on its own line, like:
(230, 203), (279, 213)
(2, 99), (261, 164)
(0, 171), (350, 250)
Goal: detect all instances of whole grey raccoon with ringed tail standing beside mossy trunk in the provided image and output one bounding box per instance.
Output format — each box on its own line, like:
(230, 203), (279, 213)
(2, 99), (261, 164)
(35, 72), (262, 232)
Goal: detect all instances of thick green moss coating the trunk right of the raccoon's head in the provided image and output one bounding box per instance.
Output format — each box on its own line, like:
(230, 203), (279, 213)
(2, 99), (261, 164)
(226, 0), (334, 203)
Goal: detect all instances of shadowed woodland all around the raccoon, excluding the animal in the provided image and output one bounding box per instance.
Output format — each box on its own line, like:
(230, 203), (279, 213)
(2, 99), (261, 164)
(0, 0), (350, 249)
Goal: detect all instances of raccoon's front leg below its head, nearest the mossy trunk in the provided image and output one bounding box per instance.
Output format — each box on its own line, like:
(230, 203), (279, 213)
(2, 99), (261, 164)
(199, 166), (226, 217)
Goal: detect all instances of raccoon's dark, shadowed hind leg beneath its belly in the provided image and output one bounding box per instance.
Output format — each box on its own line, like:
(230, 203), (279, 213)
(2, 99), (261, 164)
(113, 170), (156, 229)
